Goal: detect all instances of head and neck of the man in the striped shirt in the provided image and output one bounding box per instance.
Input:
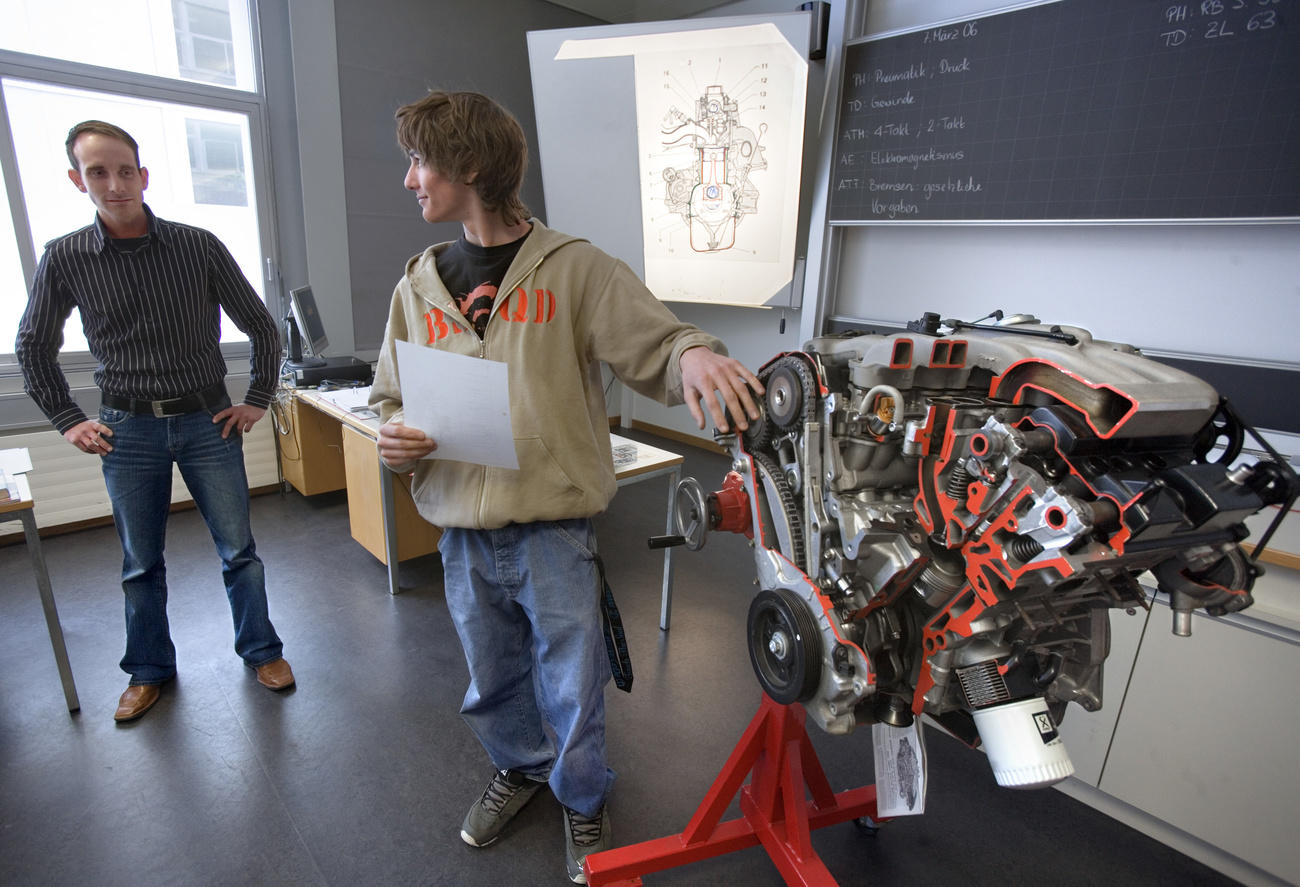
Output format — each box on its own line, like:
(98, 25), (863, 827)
(68, 133), (150, 237)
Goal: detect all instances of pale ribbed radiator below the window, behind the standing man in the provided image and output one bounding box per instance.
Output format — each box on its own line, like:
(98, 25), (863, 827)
(0, 421), (280, 540)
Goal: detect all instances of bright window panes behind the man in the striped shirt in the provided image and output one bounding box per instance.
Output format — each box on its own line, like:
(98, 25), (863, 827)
(0, 0), (272, 366)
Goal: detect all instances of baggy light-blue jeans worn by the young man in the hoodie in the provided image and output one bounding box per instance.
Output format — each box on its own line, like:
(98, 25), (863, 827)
(438, 519), (614, 815)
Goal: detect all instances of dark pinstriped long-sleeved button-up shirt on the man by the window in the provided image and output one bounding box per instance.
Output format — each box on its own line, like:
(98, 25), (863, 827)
(16, 207), (280, 433)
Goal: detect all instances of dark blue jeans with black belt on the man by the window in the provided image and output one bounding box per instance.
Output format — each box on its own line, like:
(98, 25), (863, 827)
(99, 406), (282, 684)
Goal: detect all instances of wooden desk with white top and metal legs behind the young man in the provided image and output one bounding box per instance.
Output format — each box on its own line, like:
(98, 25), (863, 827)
(277, 389), (683, 629)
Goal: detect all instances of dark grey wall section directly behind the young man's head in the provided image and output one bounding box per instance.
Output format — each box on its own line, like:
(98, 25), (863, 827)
(334, 0), (602, 352)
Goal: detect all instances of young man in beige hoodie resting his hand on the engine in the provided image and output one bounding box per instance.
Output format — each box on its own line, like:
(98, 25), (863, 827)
(371, 92), (762, 883)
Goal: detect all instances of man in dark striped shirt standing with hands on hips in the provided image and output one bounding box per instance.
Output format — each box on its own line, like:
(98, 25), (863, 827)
(16, 121), (294, 722)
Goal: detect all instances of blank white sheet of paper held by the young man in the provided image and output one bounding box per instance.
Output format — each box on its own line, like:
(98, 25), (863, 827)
(397, 341), (519, 468)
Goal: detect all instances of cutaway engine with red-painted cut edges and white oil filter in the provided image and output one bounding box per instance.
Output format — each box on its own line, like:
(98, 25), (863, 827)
(677, 315), (1300, 787)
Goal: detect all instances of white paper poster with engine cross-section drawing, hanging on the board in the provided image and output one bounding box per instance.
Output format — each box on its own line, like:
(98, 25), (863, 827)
(562, 23), (807, 307)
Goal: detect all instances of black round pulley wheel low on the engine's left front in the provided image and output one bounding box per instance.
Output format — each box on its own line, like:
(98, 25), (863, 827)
(749, 588), (822, 705)
